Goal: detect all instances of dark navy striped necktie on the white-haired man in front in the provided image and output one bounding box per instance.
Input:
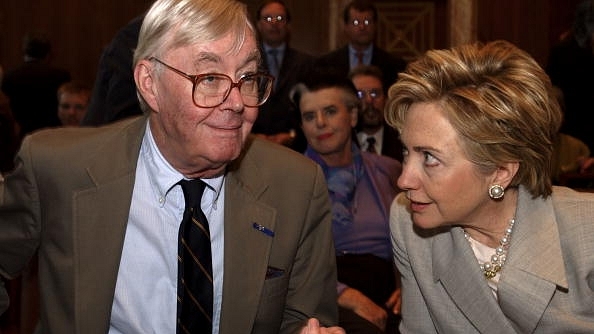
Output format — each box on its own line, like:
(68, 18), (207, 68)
(177, 179), (213, 334)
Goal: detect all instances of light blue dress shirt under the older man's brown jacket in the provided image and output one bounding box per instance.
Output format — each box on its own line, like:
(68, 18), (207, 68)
(108, 124), (225, 334)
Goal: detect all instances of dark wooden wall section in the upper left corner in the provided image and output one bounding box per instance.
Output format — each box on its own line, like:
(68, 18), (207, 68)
(0, 0), (151, 84)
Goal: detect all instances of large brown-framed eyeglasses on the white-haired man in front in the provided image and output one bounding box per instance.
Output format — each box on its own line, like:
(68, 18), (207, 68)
(149, 57), (274, 108)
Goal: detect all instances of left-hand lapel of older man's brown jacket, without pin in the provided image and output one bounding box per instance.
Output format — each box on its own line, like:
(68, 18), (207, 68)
(73, 117), (146, 333)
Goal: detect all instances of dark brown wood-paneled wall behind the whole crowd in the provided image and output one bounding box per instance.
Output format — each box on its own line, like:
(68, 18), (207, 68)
(0, 0), (579, 91)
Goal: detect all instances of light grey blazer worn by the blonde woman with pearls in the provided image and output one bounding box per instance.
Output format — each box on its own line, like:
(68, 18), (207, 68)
(390, 187), (594, 334)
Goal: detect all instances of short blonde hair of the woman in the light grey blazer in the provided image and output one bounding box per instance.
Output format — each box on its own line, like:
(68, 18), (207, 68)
(385, 41), (562, 198)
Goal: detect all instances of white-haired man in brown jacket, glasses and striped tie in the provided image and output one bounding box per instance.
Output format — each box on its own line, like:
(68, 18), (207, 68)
(0, 0), (344, 334)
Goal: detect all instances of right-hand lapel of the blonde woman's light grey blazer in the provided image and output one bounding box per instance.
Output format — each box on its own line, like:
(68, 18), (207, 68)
(499, 188), (568, 333)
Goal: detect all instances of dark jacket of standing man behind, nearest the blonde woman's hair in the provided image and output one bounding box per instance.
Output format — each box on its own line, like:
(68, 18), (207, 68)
(316, 45), (406, 90)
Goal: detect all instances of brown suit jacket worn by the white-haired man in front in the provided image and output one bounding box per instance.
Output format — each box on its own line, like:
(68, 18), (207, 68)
(0, 117), (337, 334)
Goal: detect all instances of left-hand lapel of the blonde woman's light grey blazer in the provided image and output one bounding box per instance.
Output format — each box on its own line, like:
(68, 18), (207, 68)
(432, 228), (513, 334)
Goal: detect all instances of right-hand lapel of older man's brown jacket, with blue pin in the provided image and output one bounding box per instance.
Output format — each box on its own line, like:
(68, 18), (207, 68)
(220, 144), (276, 334)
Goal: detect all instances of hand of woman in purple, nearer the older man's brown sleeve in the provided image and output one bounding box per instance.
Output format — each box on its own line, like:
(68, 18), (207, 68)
(338, 288), (388, 331)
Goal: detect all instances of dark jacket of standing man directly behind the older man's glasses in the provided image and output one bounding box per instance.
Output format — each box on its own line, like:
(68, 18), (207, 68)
(252, 45), (314, 152)
